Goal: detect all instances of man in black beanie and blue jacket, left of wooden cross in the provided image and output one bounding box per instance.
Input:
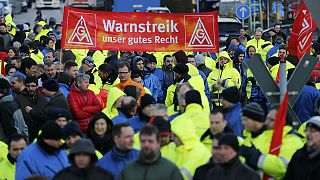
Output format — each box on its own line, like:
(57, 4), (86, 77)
(221, 86), (243, 136)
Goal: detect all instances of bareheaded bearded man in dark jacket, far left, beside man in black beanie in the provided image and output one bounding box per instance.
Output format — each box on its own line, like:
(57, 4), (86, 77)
(14, 76), (47, 142)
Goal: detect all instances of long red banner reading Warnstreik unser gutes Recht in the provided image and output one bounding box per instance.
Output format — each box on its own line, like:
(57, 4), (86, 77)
(61, 6), (219, 52)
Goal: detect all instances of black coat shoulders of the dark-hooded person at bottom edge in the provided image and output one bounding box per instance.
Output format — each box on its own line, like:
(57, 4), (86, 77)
(53, 165), (113, 180)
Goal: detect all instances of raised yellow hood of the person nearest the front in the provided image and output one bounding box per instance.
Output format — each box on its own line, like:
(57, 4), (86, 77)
(171, 119), (199, 150)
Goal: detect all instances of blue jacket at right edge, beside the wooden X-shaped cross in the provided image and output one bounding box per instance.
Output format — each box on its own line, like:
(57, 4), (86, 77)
(293, 85), (320, 123)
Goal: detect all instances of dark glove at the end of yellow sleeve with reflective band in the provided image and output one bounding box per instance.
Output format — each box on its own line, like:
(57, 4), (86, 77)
(239, 145), (262, 170)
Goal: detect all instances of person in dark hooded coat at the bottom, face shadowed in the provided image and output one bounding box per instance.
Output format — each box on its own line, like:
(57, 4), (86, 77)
(53, 138), (113, 180)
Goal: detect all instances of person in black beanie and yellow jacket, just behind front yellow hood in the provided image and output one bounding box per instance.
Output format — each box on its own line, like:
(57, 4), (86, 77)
(172, 90), (210, 139)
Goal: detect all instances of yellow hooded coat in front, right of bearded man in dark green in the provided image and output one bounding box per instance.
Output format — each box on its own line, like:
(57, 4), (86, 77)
(171, 116), (211, 179)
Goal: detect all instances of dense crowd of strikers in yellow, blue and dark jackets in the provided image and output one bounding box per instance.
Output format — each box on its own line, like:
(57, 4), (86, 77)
(0, 9), (320, 180)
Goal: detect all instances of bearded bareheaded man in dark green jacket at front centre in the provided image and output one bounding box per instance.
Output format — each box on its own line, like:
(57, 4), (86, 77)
(119, 125), (183, 180)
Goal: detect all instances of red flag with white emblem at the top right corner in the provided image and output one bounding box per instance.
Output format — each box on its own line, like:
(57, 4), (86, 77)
(287, 2), (317, 60)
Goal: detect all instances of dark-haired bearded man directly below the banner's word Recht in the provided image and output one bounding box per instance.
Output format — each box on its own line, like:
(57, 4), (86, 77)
(162, 55), (174, 99)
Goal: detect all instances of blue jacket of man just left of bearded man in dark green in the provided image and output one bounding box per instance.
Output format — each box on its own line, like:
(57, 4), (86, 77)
(97, 146), (139, 179)
